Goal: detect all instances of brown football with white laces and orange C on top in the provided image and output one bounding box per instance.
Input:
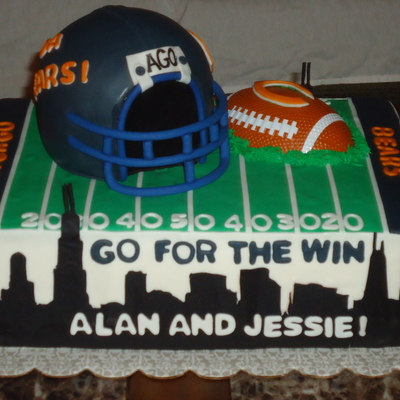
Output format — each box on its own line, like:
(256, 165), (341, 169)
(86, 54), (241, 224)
(228, 81), (354, 153)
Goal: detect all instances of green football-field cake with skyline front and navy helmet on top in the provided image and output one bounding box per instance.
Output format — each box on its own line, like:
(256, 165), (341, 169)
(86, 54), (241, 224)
(0, 7), (400, 349)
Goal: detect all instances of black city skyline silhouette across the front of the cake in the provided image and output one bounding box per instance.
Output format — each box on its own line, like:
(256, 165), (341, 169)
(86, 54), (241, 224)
(0, 186), (400, 349)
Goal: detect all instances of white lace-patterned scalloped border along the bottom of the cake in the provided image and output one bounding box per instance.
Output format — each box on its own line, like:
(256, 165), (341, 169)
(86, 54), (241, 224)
(0, 347), (400, 378)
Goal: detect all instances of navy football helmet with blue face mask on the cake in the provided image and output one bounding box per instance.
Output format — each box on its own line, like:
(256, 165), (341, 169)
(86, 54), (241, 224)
(33, 6), (229, 196)
